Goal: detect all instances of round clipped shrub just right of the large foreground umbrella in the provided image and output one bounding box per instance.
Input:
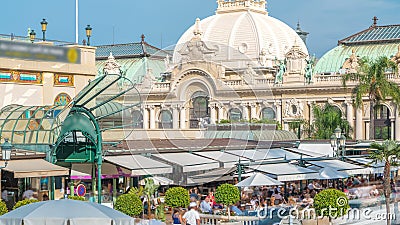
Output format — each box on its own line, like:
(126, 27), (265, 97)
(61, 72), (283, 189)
(114, 194), (143, 217)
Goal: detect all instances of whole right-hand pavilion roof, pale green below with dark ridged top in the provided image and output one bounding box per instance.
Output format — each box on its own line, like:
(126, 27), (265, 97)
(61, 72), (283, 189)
(315, 17), (400, 74)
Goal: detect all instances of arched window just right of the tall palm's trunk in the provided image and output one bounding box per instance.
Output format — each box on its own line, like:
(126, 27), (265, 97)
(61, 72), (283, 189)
(374, 105), (391, 140)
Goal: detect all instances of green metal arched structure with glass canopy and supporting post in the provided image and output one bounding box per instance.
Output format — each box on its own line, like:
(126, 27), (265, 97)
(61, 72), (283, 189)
(0, 74), (141, 203)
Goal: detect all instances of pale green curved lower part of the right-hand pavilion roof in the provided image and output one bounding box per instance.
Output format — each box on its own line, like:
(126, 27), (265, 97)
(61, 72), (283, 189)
(315, 42), (400, 74)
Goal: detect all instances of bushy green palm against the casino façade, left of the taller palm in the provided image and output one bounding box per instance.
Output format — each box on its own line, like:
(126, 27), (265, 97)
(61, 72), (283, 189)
(312, 103), (353, 140)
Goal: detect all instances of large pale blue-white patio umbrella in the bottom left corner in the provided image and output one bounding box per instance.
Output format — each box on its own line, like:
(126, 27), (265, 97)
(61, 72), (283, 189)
(0, 199), (134, 225)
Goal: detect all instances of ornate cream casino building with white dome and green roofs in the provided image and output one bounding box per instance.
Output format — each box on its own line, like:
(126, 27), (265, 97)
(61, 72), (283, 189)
(96, 0), (400, 140)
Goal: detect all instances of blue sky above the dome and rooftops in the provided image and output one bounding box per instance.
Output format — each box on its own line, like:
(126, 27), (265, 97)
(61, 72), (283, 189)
(0, 0), (400, 57)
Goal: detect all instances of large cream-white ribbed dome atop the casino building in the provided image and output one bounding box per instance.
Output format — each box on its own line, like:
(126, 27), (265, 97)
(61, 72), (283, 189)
(173, 0), (308, 68)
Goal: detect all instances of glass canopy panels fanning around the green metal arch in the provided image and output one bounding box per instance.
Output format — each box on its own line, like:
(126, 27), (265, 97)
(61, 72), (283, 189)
(0, 75), (140, 149)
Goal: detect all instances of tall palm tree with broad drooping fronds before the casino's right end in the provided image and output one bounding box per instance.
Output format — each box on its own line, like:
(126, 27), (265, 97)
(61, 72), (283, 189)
(342, 56), (400, 140)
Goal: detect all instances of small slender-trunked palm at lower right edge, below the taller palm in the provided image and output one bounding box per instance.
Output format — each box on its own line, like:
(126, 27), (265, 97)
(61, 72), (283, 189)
(369, 140), (400, 225)
